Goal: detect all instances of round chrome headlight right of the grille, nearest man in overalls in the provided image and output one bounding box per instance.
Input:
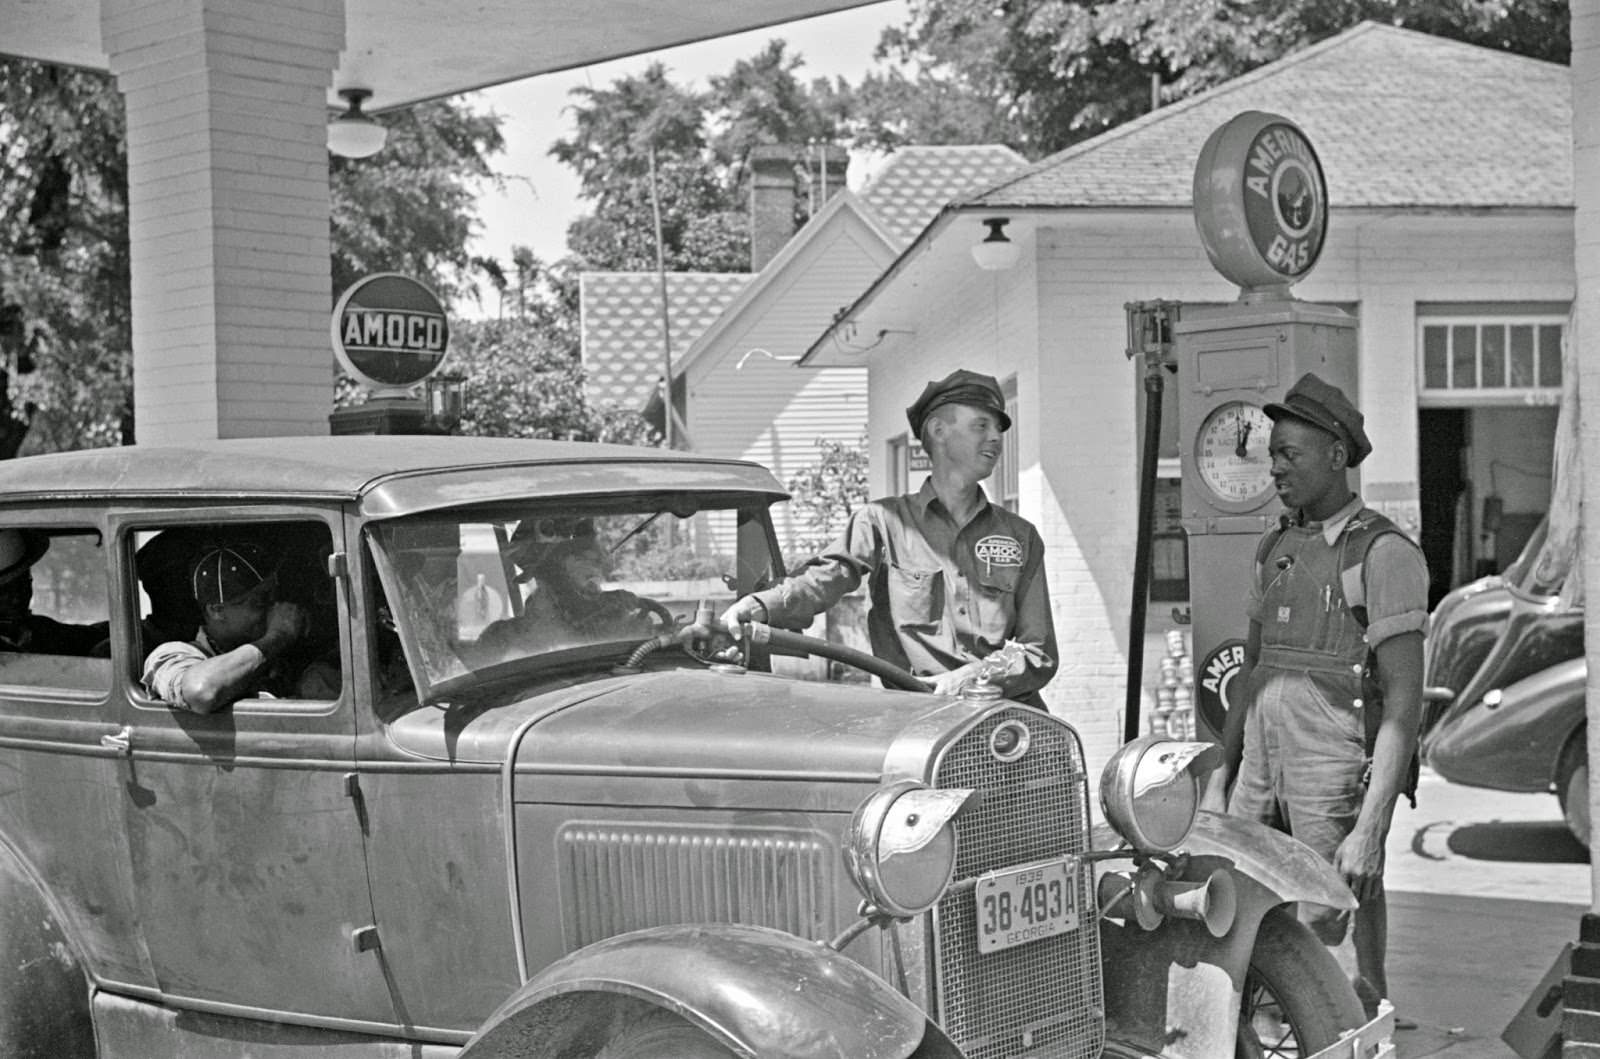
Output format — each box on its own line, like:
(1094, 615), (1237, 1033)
(1101, 736), (1222, 853)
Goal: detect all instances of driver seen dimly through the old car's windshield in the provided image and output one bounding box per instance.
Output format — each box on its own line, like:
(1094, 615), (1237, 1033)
(477, 531), (661, 657)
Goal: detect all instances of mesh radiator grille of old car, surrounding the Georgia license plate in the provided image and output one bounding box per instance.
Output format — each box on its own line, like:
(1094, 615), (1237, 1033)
(933, 707), (1106, 1059)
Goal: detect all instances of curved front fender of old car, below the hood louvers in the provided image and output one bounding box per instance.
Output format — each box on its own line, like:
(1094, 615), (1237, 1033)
(461, 923), (960, 1059)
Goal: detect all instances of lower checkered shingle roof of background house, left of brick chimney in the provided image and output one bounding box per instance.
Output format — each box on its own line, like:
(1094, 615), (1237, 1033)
(579, 272), (755, 408)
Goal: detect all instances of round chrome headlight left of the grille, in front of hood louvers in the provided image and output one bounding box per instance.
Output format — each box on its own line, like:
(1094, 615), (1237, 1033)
(845, 779), (976, 918)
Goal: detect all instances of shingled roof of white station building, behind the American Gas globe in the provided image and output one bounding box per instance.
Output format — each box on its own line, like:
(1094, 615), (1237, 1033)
(958, 22), (1573, 208)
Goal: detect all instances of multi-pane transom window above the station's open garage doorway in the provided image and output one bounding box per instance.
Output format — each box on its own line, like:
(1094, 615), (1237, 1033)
(1418, 315), (1566, 408)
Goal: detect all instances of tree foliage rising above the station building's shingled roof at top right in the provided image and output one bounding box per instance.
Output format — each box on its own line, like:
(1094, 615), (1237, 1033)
(856, 0), (1570, 157)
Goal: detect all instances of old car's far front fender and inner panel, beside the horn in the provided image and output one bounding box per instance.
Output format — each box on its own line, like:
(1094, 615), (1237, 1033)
(1101, 813), (1355, 1057)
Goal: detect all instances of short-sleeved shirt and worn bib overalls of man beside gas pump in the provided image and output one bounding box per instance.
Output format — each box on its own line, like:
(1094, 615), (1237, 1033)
(1229, 498), (1427, 861)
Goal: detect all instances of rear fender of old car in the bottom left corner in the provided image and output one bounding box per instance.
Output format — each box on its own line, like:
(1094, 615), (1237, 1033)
(0, 841), (96, 1059)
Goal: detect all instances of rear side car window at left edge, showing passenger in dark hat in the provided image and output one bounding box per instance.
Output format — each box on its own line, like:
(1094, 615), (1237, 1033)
(0, 526), (110, 694)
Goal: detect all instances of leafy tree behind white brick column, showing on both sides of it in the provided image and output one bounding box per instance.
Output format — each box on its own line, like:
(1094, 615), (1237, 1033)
(0, 58), (502, 458)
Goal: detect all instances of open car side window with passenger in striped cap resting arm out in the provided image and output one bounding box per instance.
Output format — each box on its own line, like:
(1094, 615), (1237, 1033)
(133, 522), (344, 705)
